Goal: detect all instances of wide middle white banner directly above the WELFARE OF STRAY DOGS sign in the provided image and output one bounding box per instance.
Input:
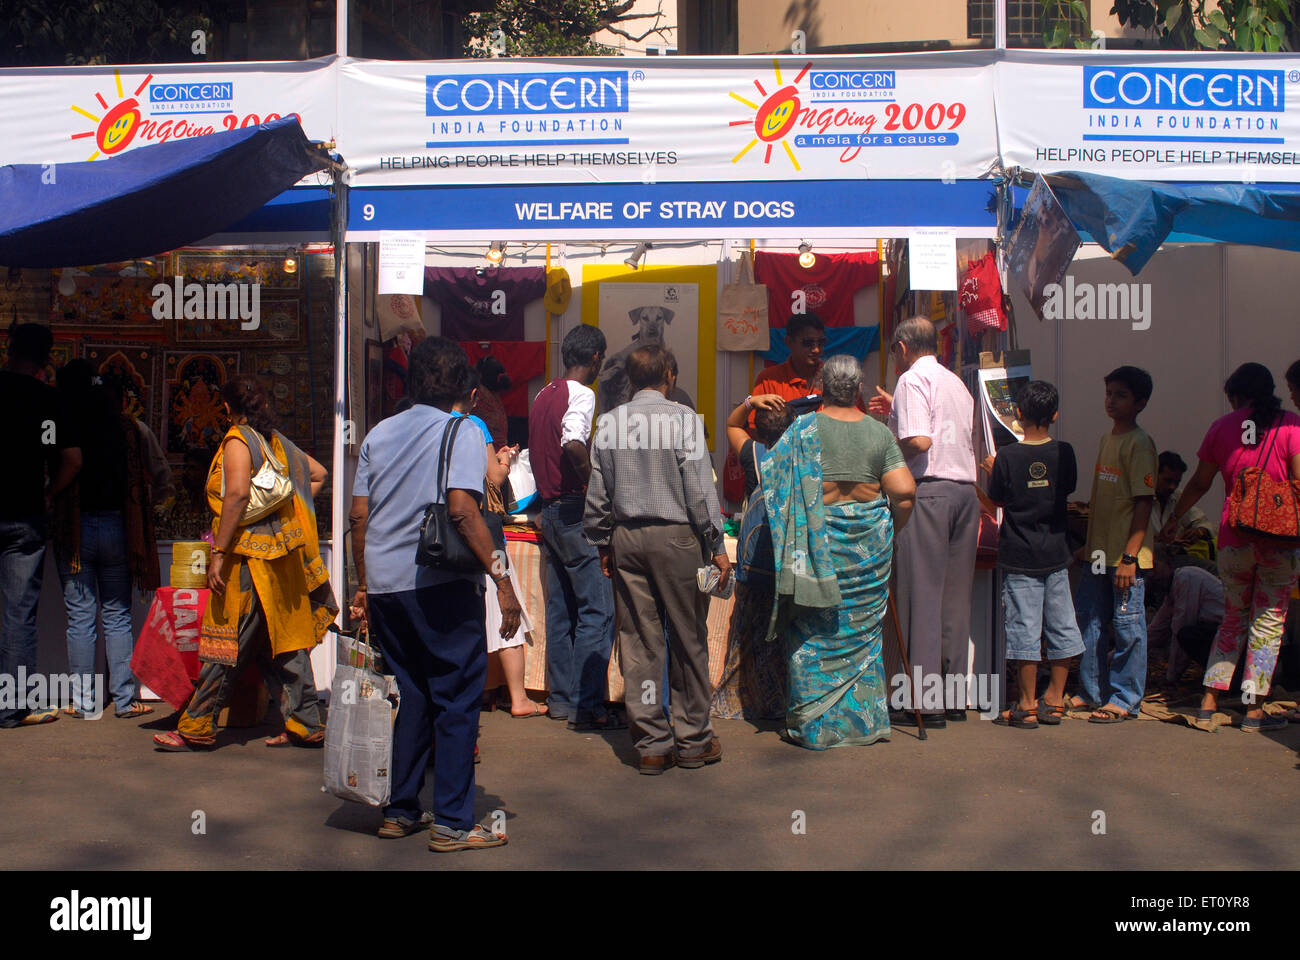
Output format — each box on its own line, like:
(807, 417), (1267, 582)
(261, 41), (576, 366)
(339, 52), (997, 186)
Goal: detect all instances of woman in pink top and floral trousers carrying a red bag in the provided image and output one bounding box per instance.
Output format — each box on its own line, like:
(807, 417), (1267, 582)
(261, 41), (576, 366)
(1158, 363), (1300, 731)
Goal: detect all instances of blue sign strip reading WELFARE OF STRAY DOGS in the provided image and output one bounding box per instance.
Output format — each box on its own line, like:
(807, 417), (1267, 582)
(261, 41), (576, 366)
(347, 180), (997, 237)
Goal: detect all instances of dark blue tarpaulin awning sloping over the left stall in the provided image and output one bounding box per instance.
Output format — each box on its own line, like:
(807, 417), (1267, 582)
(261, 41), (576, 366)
(0, 117), (329, 267)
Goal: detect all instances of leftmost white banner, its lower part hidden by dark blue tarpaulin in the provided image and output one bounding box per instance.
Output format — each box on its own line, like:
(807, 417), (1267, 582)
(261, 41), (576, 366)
(0, 56), (338, 164)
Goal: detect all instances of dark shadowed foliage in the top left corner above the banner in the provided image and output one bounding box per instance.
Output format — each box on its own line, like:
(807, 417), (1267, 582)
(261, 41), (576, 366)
(0, 0), (212, 66)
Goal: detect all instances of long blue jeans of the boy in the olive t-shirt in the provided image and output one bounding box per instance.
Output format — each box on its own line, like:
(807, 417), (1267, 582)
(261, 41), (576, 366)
(1074, 567), (1147, 713)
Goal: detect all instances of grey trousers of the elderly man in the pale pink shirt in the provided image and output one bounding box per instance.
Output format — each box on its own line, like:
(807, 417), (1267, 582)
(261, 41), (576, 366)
(887, 480), (979, 710)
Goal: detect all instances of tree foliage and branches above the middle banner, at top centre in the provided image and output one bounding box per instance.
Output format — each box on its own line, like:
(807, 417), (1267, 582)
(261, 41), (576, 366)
(462, 0), (667, 57)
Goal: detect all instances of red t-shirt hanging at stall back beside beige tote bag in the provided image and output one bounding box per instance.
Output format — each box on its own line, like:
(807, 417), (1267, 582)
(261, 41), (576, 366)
(754, 250), (880, 329)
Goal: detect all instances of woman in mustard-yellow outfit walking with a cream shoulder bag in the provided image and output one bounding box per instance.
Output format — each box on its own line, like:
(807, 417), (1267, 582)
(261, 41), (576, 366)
(153, 376), (338, 752)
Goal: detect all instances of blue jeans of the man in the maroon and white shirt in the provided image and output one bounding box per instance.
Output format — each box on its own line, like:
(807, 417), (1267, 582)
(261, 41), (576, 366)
(541, 496), (614, 722)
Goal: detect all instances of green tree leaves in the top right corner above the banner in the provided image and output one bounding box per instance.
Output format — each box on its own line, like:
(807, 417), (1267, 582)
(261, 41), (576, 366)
(1110, 0), (1300, 53)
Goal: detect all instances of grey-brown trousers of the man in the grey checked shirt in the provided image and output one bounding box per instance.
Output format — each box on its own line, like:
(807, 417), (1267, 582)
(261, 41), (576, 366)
(610, 523), (714, 756)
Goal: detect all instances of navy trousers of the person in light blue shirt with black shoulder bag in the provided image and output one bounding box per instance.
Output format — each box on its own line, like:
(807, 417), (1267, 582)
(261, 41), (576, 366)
(369, 579), (497, 830)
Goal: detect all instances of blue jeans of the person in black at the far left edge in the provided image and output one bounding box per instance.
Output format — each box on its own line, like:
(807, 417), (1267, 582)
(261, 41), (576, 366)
(0, 516), (46, 727)
